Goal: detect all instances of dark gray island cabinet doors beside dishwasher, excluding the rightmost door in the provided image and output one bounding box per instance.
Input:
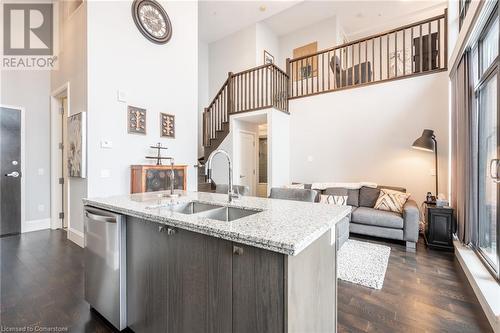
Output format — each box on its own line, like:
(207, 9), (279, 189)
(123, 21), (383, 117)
(127, 217), (232, 333)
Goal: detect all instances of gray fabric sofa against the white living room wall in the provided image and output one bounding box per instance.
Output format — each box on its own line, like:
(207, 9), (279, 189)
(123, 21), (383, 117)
(306, 185), (420, 251)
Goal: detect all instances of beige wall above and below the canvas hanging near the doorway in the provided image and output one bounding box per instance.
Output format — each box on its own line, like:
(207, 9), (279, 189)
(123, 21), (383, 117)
(50, 2), (88, 243)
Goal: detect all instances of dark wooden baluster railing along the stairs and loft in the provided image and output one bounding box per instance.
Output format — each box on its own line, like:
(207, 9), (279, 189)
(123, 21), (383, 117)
(203, 10), (448, 189)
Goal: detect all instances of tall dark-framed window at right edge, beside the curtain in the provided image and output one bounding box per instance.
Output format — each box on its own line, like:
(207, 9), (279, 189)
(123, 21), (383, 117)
(472, 9), (500, 279)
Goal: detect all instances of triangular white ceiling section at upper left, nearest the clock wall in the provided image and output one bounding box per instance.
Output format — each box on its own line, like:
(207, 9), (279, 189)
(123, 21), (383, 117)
(198, 0), (301, 43)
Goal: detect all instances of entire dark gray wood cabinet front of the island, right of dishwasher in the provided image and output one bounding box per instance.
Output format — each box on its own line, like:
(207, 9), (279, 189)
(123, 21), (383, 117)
(127, 217), (285, 333)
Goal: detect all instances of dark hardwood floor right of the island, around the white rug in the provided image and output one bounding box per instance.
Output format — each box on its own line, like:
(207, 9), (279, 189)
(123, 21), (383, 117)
(338, 233), (493, 333)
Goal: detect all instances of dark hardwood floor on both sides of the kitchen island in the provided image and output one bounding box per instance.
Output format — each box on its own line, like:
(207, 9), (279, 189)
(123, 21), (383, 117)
(0, 230), (491, 333)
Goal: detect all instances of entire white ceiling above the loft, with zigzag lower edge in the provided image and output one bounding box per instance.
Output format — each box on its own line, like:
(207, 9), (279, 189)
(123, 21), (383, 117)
(199, 0), (446, 43)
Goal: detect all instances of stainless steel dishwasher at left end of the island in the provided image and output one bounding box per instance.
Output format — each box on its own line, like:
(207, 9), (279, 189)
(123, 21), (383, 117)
(84, 206), (127, 330)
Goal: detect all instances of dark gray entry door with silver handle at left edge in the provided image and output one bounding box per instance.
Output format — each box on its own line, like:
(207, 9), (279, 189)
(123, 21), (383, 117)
(0, 107), (21, 236)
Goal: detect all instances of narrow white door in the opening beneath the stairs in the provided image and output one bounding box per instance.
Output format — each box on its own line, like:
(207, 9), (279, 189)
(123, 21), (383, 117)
(239, 132), (256, 195)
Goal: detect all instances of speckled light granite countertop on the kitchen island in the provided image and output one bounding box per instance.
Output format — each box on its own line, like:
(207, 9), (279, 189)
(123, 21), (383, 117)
(83, 191), (351, 255)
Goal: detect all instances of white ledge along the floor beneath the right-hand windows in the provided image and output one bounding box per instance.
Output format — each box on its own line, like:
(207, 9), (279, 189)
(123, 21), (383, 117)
(453, 241), (500, 333)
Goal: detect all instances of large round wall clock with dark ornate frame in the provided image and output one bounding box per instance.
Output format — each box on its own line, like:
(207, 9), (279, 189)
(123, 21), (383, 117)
(132, 0), (172, 44)
